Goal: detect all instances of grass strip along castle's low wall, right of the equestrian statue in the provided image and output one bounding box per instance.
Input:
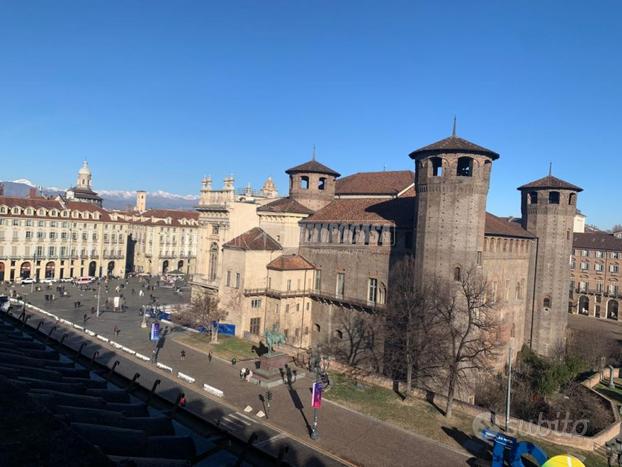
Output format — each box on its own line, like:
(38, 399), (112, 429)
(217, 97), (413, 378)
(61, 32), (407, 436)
(326, 373), (607, 467)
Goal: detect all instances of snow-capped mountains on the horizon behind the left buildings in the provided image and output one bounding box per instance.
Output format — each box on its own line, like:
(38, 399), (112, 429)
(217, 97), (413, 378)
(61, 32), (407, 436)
(0, 178), (199, 209)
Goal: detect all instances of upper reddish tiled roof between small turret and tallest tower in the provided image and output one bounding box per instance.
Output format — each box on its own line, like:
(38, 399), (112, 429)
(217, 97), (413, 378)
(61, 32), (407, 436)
(335, 170), (415, 195)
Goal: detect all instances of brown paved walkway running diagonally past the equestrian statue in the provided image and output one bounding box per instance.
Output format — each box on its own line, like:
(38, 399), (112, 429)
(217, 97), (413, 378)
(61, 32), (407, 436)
(20, 292), (478, 467)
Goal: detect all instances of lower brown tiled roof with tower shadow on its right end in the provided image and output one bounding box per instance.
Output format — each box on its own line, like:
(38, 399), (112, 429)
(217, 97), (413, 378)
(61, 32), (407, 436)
(302, 196), (415, 228)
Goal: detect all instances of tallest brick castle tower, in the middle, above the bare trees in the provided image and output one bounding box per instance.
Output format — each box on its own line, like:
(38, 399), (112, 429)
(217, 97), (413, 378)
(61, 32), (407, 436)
(410, 131), (499, 283)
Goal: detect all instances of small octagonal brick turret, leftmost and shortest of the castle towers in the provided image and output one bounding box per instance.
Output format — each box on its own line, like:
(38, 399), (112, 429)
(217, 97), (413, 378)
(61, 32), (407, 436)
(285, 154), (339, 211)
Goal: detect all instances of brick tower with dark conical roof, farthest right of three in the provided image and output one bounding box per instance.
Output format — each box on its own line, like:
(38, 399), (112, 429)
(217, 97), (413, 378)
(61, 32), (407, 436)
(518, 175), (582, 355)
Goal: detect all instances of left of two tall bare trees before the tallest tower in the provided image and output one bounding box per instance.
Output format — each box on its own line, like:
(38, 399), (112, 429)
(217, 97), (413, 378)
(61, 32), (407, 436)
(385, 255), (443, 392)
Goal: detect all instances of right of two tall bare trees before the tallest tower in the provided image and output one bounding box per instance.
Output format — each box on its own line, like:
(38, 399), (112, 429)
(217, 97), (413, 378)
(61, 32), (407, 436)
(426, 269), (499, 417)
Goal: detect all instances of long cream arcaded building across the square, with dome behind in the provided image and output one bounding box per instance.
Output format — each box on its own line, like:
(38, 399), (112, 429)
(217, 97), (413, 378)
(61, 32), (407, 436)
(0, 162), (199, 282)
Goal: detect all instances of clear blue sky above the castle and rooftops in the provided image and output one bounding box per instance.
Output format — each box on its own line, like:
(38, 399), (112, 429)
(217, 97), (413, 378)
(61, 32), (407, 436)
(0, 0), (622, 228)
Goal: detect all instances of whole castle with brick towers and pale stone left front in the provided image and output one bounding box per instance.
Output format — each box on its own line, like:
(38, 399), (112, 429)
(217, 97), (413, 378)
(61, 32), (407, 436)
(197, 134), (581, 355)
